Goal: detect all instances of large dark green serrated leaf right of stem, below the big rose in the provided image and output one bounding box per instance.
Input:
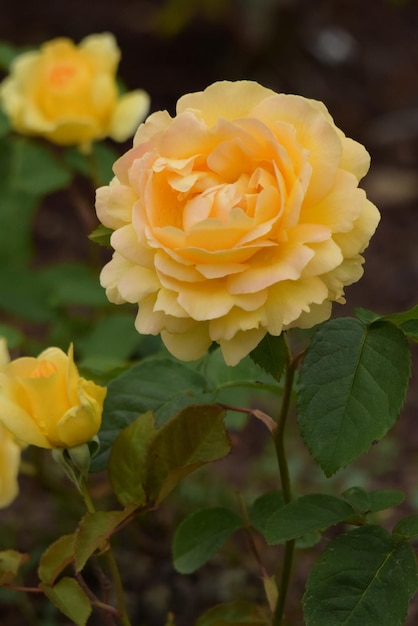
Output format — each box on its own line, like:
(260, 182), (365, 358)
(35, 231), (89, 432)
(298, 318), (410, 476)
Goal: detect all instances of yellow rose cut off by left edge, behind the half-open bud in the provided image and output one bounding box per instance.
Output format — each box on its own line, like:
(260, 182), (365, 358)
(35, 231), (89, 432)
(0, 337), (21, 508)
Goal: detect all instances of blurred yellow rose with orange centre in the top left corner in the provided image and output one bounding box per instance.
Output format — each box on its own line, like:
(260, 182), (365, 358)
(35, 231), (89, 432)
(0, 33), (149, 146)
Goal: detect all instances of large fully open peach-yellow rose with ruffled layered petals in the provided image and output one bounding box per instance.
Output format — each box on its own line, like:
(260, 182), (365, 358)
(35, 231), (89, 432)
(96, 81), (379, 365)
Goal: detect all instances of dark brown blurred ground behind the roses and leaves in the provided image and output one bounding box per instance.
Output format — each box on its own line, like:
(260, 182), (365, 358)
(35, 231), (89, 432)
(0, 0), (418, 626)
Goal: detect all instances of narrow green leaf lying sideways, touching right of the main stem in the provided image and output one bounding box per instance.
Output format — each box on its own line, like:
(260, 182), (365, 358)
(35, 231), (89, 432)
(265, 493), (354, 544)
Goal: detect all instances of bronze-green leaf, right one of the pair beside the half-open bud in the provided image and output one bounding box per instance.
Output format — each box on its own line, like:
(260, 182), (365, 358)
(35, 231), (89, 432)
(144, 404), (231, 504)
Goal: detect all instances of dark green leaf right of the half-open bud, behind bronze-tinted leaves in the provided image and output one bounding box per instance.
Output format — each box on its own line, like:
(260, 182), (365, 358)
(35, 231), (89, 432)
(92, 357), (214, 470)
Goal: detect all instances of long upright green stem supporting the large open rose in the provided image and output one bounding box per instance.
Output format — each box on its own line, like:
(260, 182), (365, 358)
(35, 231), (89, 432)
(272, 346), (299, 626)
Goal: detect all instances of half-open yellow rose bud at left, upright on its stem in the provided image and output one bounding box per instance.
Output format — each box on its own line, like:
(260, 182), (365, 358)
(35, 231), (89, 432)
(0, 346), (106, 448)
